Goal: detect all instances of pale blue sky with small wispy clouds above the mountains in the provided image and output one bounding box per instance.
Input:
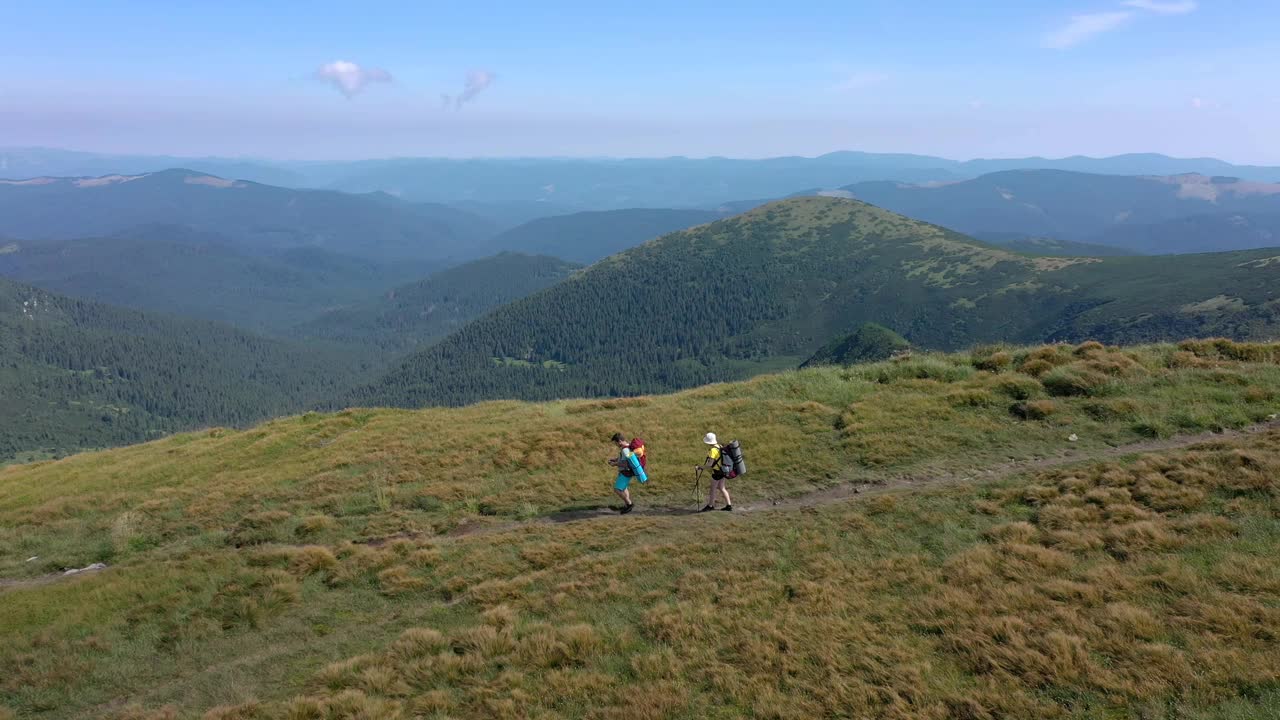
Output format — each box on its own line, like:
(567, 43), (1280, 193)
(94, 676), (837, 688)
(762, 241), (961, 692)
(0, 0), (1280, 163)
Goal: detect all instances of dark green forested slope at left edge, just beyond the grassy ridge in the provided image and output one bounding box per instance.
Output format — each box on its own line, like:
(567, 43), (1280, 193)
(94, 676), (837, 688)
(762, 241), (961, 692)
(0, 274), (356, 461)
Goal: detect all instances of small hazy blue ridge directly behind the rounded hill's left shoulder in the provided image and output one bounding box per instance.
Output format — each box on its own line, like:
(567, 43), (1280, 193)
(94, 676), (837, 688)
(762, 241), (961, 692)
(486, 209), (724, 264)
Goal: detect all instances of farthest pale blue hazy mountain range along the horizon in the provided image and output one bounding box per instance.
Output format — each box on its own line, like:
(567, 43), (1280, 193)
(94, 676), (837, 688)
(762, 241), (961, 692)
(10, 149), (1280, 208)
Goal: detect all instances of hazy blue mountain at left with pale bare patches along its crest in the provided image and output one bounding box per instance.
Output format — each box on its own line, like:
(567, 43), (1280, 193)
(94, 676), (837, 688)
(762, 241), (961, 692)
(0, 169), (489, 261)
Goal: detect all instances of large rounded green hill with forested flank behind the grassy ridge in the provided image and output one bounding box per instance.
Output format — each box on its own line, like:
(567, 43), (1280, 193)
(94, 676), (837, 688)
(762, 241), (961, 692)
(349, 197), (1280, 406)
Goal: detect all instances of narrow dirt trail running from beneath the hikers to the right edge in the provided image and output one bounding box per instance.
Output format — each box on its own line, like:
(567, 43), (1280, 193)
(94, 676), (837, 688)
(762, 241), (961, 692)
(449, 420), (1280, 537)
